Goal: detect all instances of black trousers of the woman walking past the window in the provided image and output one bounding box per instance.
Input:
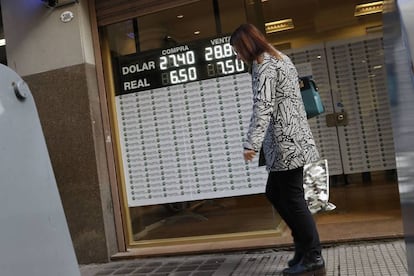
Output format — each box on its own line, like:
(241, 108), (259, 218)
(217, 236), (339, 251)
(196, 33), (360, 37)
(266, 167), (321, 253)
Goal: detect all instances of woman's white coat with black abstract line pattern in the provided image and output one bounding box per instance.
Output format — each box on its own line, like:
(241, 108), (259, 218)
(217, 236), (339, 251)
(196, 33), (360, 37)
(243, 49), (319, 171)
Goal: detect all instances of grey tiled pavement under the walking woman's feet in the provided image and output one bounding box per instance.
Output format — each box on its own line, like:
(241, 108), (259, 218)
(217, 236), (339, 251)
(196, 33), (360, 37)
(80, 239), (408, 276)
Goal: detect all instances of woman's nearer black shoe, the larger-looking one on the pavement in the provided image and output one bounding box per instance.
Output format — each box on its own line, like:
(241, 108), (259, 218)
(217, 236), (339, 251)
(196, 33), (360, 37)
(283, 252), (326, 276)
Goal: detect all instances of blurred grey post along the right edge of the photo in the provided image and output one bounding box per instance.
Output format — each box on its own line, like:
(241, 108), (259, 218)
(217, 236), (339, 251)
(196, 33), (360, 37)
(384, 0), (414, 275)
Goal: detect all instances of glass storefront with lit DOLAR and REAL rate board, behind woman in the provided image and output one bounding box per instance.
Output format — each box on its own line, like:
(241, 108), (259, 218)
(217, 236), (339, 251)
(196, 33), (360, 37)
(95, 0), (402, 256)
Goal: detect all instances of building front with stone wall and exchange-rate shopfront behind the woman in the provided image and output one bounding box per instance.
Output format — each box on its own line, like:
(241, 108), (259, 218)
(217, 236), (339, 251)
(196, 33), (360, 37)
(1, 0), (410, 272)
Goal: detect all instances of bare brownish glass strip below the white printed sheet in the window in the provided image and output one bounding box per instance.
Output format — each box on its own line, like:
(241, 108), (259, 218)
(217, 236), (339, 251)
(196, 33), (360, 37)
(130, 195), (282, 241)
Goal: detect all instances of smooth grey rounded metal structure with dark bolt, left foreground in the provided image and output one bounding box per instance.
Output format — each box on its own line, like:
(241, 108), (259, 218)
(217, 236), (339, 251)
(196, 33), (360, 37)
(0, 65), (80, 276)
